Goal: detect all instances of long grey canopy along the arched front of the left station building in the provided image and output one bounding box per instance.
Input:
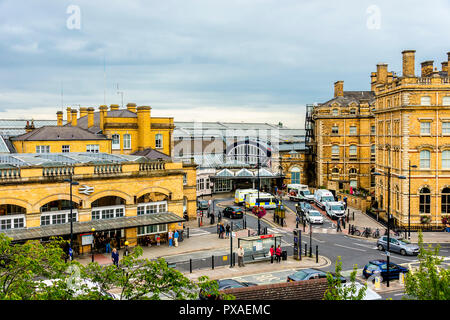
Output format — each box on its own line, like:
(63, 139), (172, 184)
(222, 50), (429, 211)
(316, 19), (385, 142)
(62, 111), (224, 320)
(1, 212), (186, 241)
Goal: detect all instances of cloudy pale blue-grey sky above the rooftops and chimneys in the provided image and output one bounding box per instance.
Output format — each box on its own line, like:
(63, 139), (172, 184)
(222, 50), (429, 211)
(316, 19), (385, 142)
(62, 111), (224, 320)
(0, 0), (450, 127)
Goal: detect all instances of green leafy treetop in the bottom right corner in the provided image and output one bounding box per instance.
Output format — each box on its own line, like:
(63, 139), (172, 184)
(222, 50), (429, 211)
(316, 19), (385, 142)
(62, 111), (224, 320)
(403, 230), (450, 300)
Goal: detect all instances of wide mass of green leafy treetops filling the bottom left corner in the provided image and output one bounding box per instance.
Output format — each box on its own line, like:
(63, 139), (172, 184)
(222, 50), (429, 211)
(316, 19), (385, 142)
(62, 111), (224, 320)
(0, 233), (233, 300)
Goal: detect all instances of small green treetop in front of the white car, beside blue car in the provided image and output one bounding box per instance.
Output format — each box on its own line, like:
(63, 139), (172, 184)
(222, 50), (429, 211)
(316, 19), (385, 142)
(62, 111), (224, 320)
(323, 256), (367, 300)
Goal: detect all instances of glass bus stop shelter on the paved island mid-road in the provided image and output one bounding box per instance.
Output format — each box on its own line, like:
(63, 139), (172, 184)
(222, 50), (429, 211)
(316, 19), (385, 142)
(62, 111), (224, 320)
(238, 233), (283, 262)
